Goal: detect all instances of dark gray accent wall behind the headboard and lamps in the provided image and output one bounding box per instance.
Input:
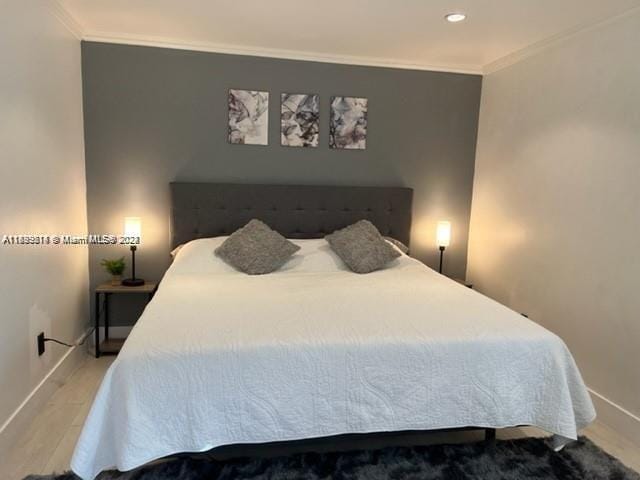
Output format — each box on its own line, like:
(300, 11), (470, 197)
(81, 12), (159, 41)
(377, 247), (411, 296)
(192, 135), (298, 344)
(82, 42), (482, 325)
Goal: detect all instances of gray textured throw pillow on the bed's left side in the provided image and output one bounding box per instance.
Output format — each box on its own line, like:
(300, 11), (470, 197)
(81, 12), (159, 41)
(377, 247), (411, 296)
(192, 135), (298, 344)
(215, 219), (300, 275)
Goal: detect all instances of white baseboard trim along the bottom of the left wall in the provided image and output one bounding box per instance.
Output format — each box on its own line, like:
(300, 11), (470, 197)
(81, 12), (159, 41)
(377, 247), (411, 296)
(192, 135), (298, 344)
(0, 330), (90, 452)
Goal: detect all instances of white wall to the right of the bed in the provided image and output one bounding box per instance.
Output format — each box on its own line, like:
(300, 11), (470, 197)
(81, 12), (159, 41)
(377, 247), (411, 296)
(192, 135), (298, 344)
(467, 13), (640, 438)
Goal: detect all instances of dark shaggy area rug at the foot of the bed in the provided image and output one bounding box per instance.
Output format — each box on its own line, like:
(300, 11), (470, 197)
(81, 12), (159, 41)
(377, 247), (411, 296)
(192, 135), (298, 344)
(27, 438), (640, 480)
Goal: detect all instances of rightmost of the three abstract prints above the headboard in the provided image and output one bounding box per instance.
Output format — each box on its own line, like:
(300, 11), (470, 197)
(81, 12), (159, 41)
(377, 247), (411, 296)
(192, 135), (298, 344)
(329, 97), (367, 150)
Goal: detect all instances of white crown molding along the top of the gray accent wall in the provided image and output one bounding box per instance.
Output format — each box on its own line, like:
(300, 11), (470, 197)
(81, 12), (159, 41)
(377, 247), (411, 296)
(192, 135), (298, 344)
(82, 31), (482, 75)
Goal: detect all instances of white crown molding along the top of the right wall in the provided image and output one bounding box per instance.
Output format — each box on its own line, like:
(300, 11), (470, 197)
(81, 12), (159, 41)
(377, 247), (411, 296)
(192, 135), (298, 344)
(482, 6), (640, 75)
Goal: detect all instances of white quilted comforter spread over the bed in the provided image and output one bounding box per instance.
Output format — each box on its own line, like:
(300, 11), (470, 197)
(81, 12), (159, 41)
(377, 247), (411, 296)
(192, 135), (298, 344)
(72, 239), (595, 480)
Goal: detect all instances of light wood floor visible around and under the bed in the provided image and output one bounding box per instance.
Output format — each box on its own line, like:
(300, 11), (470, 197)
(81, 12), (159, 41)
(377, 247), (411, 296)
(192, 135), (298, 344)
(0, 355), (640, 480)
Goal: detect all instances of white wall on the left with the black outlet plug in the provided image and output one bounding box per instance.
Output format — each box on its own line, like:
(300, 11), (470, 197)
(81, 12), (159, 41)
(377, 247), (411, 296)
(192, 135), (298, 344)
(0, 0), (88, 426)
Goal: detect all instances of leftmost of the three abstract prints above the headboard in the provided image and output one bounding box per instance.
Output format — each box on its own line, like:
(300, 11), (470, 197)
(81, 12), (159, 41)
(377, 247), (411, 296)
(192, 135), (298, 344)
(228, 90), (269, 145)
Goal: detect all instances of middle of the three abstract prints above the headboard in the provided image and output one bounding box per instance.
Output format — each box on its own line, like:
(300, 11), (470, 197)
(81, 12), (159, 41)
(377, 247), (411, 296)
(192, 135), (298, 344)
(280, 93), (320, 147)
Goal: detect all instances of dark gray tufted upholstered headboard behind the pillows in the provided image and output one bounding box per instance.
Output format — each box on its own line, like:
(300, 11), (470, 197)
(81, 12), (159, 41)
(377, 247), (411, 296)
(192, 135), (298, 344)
(171, 182), (413, 248)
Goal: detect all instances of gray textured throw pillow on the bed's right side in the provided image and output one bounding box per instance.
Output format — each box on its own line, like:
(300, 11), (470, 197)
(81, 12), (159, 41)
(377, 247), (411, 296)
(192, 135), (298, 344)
(324, 220), (400, 273)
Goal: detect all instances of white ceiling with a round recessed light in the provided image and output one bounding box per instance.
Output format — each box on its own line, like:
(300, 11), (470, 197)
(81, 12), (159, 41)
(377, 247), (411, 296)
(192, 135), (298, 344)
(51, 0), (640, 73)
